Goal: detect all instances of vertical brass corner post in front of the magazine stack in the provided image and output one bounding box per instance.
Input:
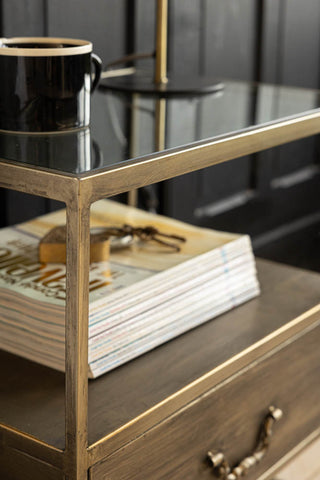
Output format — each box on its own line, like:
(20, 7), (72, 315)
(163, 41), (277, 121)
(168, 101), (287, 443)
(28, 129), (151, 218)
(65, 195), (90, 480)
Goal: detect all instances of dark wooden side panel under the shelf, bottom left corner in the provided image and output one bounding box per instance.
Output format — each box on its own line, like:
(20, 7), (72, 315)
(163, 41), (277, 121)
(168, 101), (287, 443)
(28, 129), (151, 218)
(0, 446), (64, 480)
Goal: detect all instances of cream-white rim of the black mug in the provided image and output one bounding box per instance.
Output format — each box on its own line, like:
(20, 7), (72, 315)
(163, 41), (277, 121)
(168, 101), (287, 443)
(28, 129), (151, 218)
(0, 37), (92, 57)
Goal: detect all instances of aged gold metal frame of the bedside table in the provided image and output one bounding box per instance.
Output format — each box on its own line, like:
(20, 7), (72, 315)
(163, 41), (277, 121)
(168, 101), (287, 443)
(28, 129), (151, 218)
(0, 110), (320, 480)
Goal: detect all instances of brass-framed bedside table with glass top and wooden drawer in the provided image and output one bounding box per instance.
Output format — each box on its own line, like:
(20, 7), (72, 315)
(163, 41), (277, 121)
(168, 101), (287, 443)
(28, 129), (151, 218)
(0, 81), (320, 480)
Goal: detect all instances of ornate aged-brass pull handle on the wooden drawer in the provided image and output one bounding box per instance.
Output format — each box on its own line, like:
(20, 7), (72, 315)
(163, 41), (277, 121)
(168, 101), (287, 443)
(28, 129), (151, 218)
(208, 406), (282, 480)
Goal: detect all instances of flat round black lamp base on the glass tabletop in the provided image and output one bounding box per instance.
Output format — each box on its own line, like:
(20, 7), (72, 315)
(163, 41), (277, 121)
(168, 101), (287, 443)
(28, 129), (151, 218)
(99, 74), (224, 97)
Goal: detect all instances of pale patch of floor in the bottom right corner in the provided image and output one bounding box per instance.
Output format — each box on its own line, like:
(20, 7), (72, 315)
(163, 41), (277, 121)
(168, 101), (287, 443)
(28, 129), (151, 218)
(274, 439), (320, 480)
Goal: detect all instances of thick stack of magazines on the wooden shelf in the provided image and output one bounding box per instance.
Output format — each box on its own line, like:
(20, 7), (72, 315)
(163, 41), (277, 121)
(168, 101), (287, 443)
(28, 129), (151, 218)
(0, 200), (259, 378)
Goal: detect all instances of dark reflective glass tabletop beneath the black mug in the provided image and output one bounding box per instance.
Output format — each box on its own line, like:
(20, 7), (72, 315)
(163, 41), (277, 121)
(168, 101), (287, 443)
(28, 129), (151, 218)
(0, 80), (320, 175)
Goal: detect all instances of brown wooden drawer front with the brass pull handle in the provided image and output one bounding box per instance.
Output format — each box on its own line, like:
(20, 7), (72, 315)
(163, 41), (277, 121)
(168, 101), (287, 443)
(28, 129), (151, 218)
(90, 326), (320, 480)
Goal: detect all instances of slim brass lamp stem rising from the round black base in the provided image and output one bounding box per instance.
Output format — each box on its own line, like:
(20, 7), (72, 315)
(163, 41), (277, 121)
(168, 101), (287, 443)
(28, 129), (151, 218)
(154, 0), (168, 84)
